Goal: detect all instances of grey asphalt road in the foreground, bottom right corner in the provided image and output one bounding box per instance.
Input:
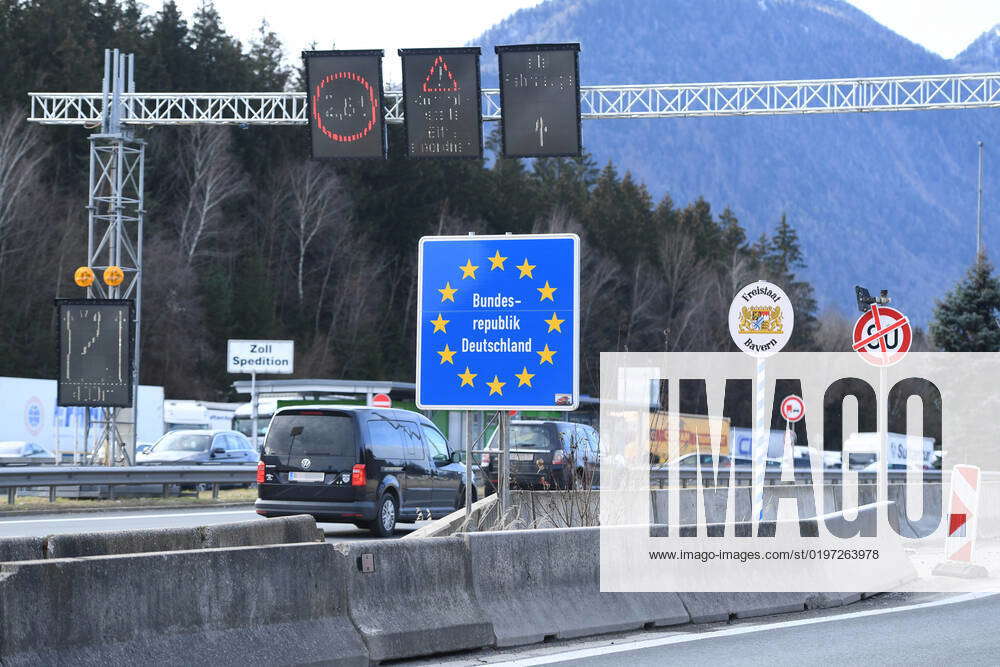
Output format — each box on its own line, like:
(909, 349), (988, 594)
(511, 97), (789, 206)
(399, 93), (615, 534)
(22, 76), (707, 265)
(477, 594), (1000, 667)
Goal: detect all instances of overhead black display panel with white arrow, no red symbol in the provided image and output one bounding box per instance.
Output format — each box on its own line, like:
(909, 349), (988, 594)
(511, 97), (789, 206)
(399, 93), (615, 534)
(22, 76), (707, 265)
(496, 44), (581, 157)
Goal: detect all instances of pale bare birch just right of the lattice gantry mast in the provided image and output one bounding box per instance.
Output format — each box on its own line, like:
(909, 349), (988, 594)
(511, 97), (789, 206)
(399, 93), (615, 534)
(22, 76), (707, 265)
(178, 125), (247, 265)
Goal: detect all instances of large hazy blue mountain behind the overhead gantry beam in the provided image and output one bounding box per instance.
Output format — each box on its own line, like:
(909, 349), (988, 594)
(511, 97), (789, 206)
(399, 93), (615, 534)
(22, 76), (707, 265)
(473, 0), (1000, 324)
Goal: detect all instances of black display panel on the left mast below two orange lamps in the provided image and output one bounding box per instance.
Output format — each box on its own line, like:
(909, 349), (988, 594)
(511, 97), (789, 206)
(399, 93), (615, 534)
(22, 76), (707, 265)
(56, 299), (135, 408)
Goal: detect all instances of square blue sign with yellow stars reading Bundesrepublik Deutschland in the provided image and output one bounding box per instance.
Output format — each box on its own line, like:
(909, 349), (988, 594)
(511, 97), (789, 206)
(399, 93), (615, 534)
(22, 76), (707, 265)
(417, 234), (580, 410)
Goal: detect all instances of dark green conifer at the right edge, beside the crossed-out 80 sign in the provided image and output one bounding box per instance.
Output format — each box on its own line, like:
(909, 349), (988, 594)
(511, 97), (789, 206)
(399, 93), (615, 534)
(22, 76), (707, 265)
(930, 255), (1000, 352)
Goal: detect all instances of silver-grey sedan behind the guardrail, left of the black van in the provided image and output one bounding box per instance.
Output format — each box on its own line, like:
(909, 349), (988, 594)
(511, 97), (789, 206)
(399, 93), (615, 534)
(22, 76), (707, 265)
(135, 429), (259, 465)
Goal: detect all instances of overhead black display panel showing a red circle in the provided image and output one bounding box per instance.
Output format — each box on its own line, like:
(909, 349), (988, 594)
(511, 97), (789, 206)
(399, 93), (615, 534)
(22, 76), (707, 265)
(302, 50), (385, 158)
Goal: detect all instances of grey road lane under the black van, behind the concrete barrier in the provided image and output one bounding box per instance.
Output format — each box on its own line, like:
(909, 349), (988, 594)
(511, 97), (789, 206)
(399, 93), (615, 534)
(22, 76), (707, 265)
(0, 507), (428, 542)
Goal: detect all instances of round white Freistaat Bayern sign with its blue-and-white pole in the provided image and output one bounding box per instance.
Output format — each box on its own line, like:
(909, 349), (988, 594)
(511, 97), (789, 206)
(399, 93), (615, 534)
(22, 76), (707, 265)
(729, 280), (795, 530)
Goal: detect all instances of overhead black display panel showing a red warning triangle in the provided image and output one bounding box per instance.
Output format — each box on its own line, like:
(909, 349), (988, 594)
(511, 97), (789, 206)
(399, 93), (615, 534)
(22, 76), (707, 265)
(399, 47), (483, 158)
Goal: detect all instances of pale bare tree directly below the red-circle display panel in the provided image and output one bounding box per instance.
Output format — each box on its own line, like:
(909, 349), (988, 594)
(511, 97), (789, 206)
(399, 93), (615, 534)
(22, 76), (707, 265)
(285, 161), (351, 304)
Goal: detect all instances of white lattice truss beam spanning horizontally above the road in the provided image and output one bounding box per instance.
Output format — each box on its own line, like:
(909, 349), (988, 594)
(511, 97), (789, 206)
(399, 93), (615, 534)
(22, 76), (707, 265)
(28, 73), (1000, 127)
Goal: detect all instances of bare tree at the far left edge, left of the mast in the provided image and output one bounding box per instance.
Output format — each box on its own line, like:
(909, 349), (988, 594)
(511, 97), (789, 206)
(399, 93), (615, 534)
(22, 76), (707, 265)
(0, 108), (49, 267)
